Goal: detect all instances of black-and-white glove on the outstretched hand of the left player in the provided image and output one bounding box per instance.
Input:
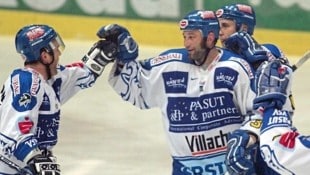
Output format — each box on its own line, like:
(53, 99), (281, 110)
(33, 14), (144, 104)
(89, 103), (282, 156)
(82, 40), (117, 76)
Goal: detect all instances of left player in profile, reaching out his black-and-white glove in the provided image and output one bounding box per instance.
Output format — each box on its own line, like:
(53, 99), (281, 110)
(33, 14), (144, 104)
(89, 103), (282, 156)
(0, 24), (116, 175)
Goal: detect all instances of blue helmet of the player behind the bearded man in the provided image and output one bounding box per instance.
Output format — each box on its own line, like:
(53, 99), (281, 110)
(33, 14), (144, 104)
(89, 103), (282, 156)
(216, 4), (256, 35)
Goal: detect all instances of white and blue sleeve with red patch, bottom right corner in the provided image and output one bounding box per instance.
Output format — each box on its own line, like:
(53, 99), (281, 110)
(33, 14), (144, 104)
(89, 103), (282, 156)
(260, 109), (310, 174)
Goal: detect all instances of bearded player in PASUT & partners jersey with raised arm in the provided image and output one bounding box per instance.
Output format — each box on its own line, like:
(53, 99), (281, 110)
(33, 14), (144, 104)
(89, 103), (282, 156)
(94, 10), (272, 175)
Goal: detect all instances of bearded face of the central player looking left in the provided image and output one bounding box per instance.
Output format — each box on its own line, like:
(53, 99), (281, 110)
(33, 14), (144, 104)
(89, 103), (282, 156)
(183, 30), (206, 62)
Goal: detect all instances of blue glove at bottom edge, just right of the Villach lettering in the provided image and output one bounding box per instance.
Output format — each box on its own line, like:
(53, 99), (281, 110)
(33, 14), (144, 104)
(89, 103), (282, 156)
(225, 129), (258, 175)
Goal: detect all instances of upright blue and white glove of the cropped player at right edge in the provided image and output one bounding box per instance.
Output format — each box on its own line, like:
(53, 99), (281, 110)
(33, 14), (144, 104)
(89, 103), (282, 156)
(253, 60), (293, 109)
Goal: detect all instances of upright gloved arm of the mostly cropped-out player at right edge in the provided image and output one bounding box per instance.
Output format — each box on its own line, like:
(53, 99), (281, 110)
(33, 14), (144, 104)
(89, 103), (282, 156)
(254, 60), (310, 175)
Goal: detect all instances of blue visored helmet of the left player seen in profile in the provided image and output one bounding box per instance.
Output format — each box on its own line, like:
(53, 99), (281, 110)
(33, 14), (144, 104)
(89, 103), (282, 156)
(15, 24), (65, 62)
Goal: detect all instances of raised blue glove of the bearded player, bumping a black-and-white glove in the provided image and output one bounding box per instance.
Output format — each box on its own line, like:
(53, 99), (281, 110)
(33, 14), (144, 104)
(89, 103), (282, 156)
(97, 24), (139, 63)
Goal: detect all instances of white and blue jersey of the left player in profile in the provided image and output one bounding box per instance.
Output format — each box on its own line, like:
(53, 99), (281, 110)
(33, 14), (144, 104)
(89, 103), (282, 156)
(0, 63), (96, 174)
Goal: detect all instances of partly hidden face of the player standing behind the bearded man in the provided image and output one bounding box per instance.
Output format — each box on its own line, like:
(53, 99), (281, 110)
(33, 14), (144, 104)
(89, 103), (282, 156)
(219, 18), (237, 46)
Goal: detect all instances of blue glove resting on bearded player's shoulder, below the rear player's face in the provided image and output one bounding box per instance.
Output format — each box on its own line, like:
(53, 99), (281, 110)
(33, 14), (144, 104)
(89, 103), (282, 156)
(225, 32), (268, 66)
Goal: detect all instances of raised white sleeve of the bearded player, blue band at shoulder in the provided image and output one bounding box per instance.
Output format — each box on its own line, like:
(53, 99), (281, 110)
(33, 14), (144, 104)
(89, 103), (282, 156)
(109, 49), (187, 109)
